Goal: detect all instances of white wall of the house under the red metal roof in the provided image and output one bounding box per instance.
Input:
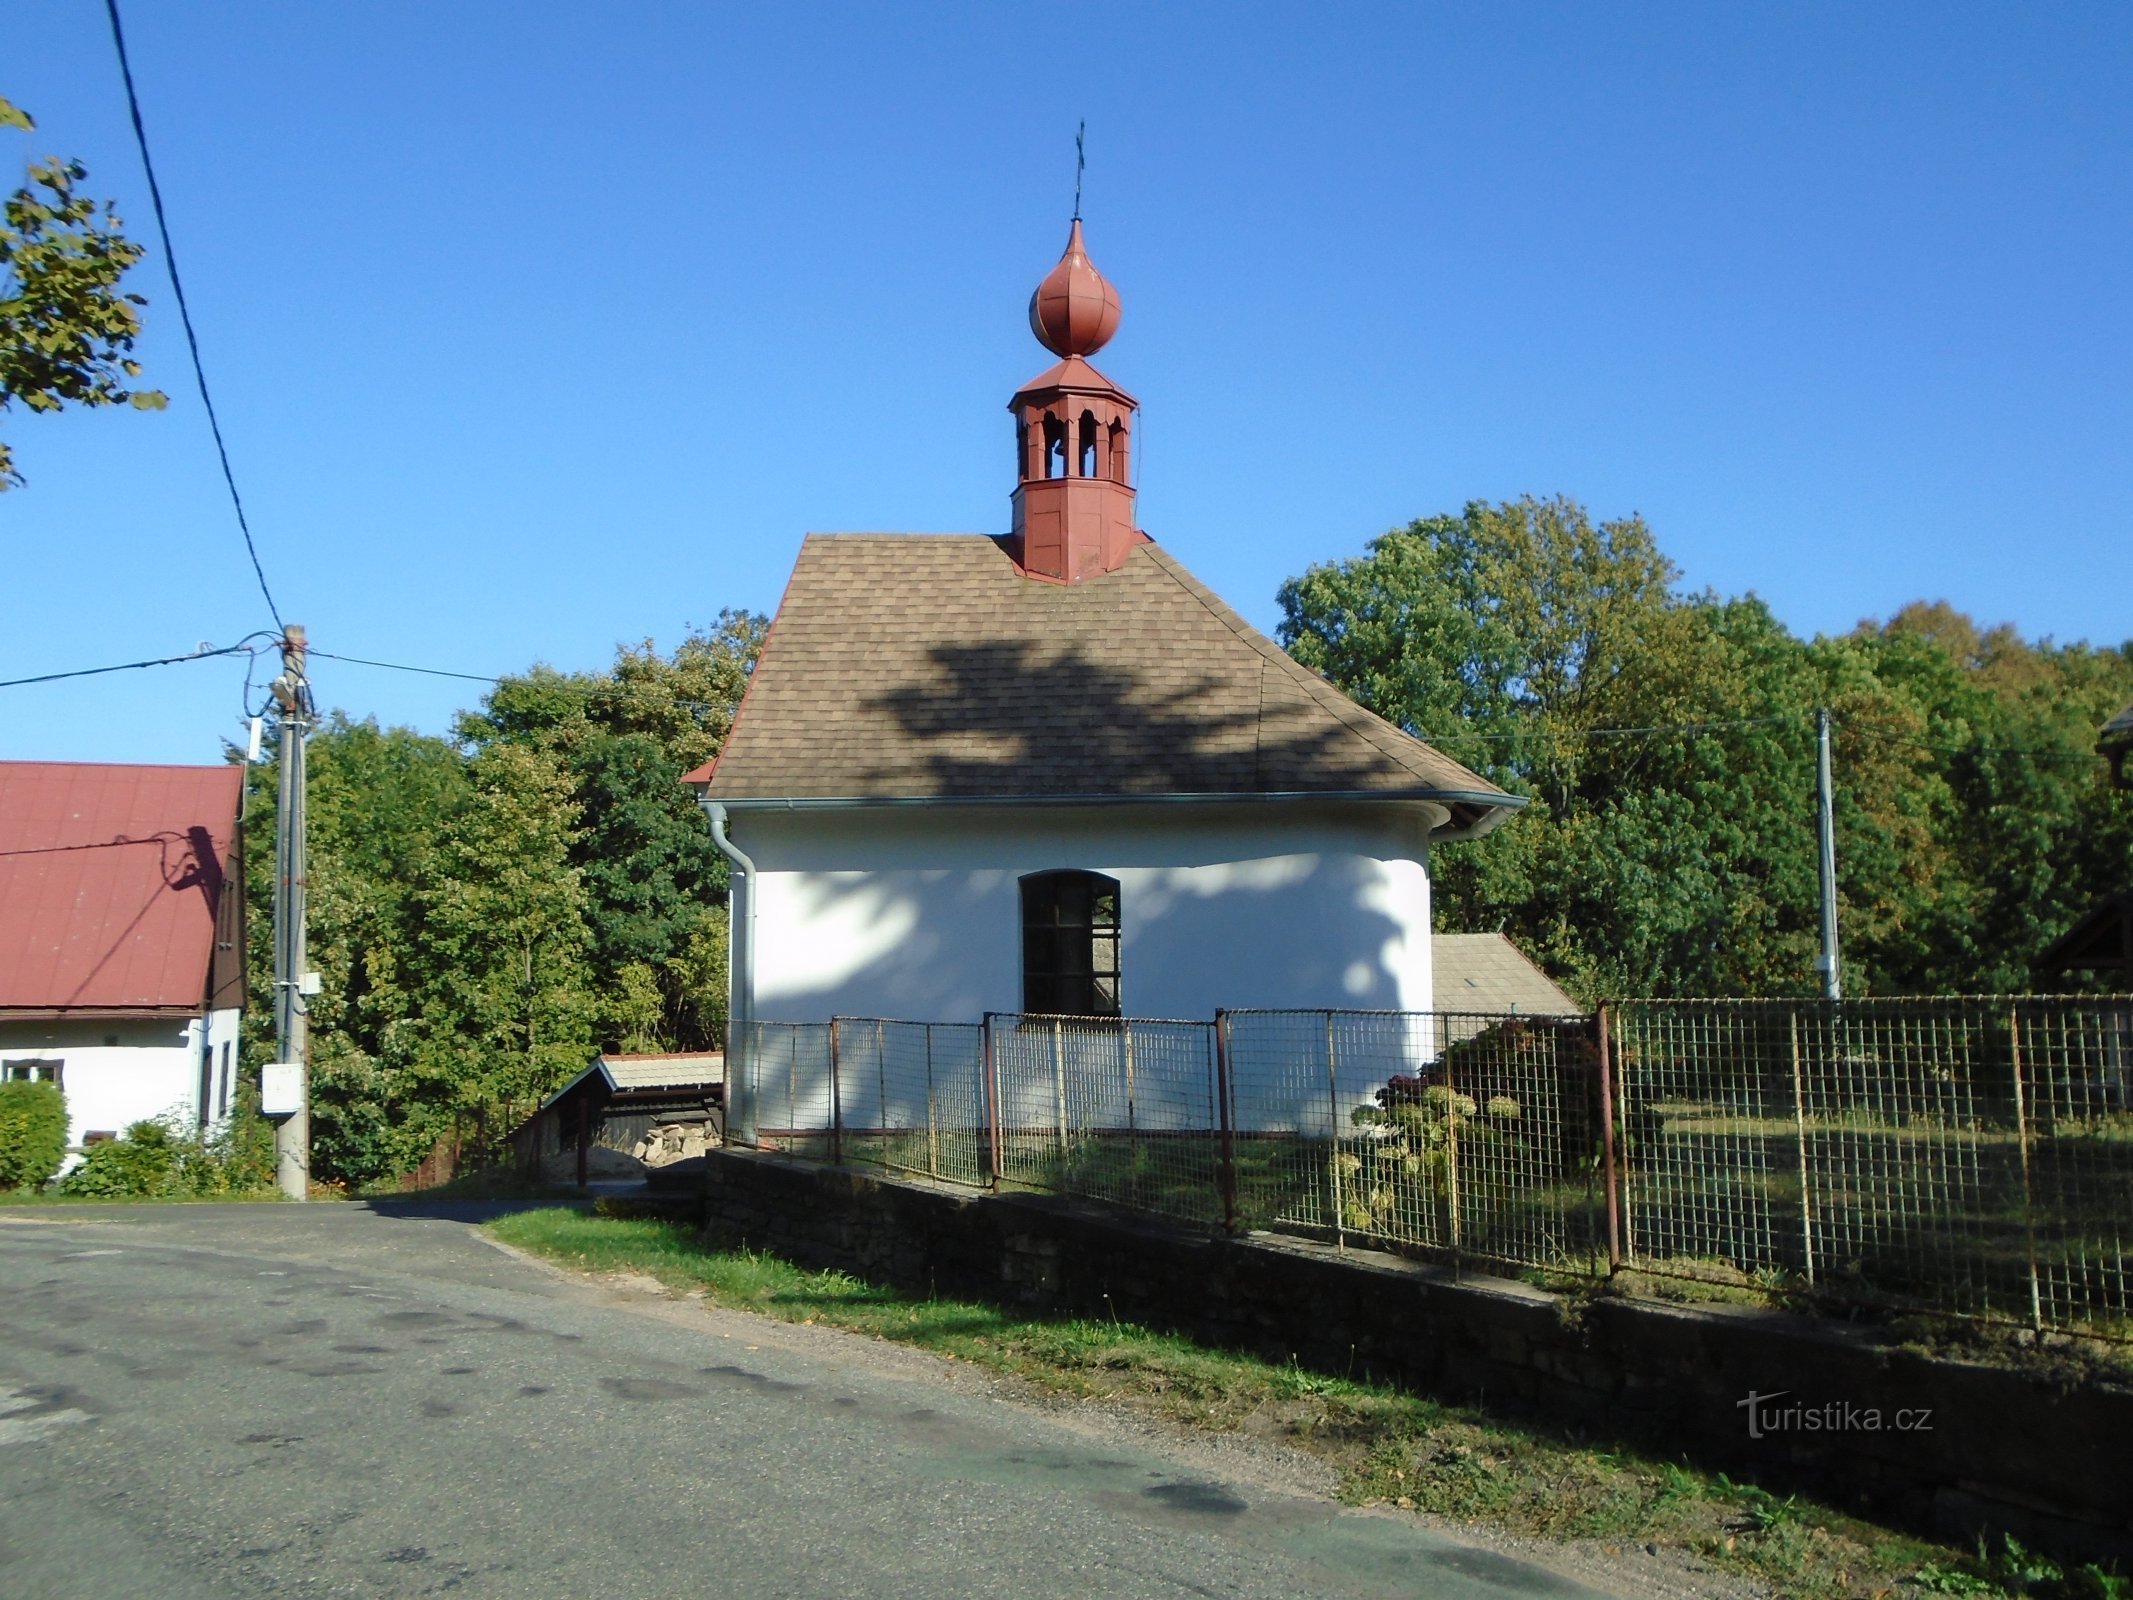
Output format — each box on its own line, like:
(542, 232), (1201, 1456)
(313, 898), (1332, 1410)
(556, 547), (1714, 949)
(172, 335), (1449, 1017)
(0, 1011), (239, 1165)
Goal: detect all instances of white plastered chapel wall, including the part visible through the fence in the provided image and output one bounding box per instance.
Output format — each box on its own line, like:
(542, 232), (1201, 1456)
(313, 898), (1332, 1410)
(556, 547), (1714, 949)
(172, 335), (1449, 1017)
(734, 804), (1431, 1131)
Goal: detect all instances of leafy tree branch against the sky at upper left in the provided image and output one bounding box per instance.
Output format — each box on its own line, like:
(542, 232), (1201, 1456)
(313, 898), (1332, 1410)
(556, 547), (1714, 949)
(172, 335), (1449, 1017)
(0, 100), (169, 491)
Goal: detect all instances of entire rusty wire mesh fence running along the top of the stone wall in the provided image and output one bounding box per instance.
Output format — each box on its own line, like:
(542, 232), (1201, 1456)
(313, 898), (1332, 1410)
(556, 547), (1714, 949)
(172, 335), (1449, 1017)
(725, 996), (2133, 1340)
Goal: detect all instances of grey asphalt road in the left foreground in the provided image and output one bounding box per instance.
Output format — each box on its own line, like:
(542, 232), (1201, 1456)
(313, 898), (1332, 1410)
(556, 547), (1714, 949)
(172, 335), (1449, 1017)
(0, 1205), (1589, 1600)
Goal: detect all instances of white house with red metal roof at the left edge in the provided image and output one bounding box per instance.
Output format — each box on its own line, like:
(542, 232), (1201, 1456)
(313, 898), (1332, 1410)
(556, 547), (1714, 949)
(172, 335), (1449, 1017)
(0, 762), (245, 1150)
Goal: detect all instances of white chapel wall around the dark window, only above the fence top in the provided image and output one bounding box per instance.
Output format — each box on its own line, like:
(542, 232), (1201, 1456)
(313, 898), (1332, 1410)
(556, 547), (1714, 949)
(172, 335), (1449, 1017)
(734, 804), (1431, 1022)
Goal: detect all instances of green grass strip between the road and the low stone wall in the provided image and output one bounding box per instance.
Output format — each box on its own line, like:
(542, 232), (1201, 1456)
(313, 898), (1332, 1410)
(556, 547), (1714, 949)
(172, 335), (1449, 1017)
(486, 1207), (2114, 1598)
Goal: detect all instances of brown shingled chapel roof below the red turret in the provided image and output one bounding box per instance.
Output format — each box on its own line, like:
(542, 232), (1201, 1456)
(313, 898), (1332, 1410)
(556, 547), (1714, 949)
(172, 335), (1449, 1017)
(689, 533), (1523, 828)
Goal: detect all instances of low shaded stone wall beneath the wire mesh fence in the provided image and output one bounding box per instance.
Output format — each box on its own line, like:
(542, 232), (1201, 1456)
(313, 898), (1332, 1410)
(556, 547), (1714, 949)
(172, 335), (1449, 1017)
(704, 1150), (2133, 1559)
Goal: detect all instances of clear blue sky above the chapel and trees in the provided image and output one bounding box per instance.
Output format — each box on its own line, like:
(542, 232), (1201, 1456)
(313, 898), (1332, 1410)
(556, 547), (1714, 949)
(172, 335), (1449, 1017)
(0, 0), (2133, 762)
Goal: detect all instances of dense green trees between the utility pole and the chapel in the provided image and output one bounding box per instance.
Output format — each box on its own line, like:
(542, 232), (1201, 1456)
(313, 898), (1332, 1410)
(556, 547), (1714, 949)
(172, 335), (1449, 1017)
(247, 612), (766, 1182)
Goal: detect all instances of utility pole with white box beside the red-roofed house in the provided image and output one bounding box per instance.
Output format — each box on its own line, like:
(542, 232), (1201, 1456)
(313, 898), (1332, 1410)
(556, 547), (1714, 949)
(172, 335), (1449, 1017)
(260, 625), (314, 1201)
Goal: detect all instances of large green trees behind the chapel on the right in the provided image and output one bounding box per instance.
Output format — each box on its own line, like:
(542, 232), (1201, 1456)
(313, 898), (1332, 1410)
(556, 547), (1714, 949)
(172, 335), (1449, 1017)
(1280, 499), (2133, 996)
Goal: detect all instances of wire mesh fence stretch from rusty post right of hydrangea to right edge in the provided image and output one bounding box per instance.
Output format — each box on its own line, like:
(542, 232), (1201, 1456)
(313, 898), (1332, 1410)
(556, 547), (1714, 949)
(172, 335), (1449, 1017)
(1610, 996), (2133, 1340)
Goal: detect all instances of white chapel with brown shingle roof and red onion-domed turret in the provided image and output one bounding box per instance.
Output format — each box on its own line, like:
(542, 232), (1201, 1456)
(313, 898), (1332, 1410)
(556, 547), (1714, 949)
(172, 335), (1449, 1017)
(687, 220), (1523, 1135)
